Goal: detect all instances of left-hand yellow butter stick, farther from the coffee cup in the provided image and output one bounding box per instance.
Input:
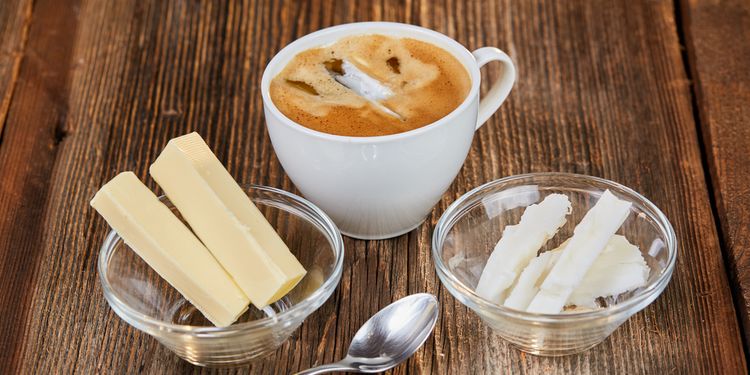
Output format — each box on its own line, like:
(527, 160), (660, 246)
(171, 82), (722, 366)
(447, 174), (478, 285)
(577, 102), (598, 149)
(91, 172), (249, 327)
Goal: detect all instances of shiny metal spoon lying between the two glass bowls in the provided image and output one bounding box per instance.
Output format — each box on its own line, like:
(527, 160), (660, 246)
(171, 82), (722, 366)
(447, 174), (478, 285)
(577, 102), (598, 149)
(296, 293), (438, 375)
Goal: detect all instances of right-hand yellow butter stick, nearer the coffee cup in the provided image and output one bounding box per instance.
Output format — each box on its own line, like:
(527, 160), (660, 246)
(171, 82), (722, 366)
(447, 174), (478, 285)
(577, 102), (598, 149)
(150, 133), (305, 309)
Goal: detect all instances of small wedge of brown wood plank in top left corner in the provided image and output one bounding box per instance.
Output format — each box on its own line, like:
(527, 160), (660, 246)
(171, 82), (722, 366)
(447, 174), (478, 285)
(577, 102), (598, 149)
(0, 0), (33, 135)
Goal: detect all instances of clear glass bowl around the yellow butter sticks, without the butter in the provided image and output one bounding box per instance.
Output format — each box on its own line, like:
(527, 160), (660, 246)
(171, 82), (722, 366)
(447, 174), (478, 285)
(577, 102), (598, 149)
(99, 185), (344, 367)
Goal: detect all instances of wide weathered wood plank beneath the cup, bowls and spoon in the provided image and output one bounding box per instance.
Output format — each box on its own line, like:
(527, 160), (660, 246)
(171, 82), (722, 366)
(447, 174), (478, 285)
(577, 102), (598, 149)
(0, 0), (746, 374)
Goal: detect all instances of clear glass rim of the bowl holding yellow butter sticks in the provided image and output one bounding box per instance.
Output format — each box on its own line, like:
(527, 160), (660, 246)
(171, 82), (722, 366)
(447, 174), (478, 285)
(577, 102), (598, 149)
(97, 184), (344, 337)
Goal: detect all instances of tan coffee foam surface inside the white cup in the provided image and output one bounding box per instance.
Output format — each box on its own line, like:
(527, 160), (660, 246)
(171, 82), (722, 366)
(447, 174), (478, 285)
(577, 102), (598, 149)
(270, 35), (470, 136)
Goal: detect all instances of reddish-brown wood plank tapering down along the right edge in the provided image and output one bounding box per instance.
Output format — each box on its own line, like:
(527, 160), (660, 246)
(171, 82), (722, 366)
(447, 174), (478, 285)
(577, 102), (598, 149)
(681, 1), (750, 350)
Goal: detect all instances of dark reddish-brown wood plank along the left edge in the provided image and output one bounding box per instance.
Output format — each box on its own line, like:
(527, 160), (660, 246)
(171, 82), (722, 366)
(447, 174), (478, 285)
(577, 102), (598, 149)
(0, 0), (77, 373)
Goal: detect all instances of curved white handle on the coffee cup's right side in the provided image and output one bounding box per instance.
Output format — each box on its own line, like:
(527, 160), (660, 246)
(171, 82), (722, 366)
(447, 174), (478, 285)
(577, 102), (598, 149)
(471, 47), (516, 129)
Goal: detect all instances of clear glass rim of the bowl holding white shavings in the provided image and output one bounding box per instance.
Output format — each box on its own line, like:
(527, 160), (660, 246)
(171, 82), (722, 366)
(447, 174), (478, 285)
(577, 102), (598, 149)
(431, 172), (678, 324)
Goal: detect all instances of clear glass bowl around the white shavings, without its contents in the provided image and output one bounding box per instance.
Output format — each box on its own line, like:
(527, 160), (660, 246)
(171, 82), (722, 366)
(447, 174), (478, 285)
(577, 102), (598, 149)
(432, 173), (677, 356)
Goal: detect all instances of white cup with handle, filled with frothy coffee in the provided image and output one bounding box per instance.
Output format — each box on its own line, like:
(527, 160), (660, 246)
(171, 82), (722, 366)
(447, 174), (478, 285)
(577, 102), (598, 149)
(261, 22), (516, 239)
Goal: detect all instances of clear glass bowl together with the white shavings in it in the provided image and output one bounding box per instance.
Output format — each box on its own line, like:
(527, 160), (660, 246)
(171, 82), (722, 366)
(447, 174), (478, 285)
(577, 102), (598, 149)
(432, 173), (677, 356)
